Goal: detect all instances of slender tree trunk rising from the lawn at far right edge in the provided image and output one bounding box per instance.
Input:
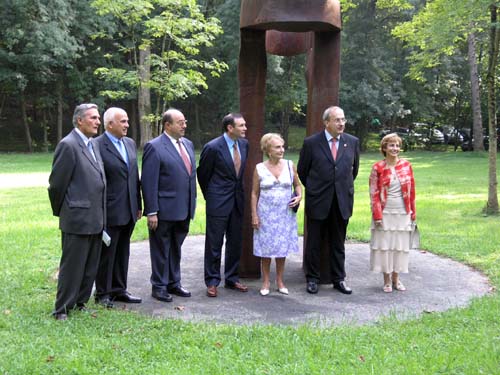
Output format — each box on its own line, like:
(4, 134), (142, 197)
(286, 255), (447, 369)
(486, 5), (500, 214)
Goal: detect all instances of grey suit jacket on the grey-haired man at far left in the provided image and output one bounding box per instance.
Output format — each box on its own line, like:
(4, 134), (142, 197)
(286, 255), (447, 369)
(48, 129), (106, 235)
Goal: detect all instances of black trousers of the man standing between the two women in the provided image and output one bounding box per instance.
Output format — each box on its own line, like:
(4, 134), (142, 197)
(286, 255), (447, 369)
(304, 195), (349, 283)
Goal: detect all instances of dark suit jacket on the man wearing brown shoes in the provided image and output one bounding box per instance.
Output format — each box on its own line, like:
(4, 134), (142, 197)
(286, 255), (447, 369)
(197, 136), (248, 216)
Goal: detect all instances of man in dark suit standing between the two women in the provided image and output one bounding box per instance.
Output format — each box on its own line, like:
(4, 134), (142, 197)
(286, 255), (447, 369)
(297, 107), (359, 294)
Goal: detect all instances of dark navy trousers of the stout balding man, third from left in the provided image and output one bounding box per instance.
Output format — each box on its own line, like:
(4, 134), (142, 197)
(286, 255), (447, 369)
(149, 218), (189, 291)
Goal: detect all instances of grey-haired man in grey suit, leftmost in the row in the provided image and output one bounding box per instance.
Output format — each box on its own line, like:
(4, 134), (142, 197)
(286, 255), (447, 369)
(48, 104), (106, 320)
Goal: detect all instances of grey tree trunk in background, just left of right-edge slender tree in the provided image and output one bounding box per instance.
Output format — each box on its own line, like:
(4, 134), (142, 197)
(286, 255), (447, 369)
(468, 33), (484, 152)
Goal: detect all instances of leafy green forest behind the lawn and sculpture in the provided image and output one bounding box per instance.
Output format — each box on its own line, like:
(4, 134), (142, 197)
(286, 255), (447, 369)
(0, 0), (500, 158)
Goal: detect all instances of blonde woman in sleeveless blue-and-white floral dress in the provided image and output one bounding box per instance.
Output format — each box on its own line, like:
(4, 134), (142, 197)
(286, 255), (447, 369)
(251, 133), (302, 296)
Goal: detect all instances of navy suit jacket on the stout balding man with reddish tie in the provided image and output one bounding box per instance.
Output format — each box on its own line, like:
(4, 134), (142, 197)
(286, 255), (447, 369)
(141, 133), (196, 221)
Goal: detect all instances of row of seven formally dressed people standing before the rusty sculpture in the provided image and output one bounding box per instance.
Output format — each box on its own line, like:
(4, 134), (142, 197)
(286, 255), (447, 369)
(49, 104), (415, 320)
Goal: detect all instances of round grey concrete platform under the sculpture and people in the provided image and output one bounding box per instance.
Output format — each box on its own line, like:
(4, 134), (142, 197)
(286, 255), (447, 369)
(122, 236), (490, 326)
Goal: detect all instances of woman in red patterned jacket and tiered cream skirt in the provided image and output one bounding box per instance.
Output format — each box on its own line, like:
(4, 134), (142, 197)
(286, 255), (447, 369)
(370, 133), (416, 293)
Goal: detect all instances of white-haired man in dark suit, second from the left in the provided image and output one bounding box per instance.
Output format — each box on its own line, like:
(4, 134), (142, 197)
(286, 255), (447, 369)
(94, 107), (142, 307)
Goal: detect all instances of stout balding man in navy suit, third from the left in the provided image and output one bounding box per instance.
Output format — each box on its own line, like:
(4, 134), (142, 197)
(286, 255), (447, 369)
(141, 109), (196, 302)
